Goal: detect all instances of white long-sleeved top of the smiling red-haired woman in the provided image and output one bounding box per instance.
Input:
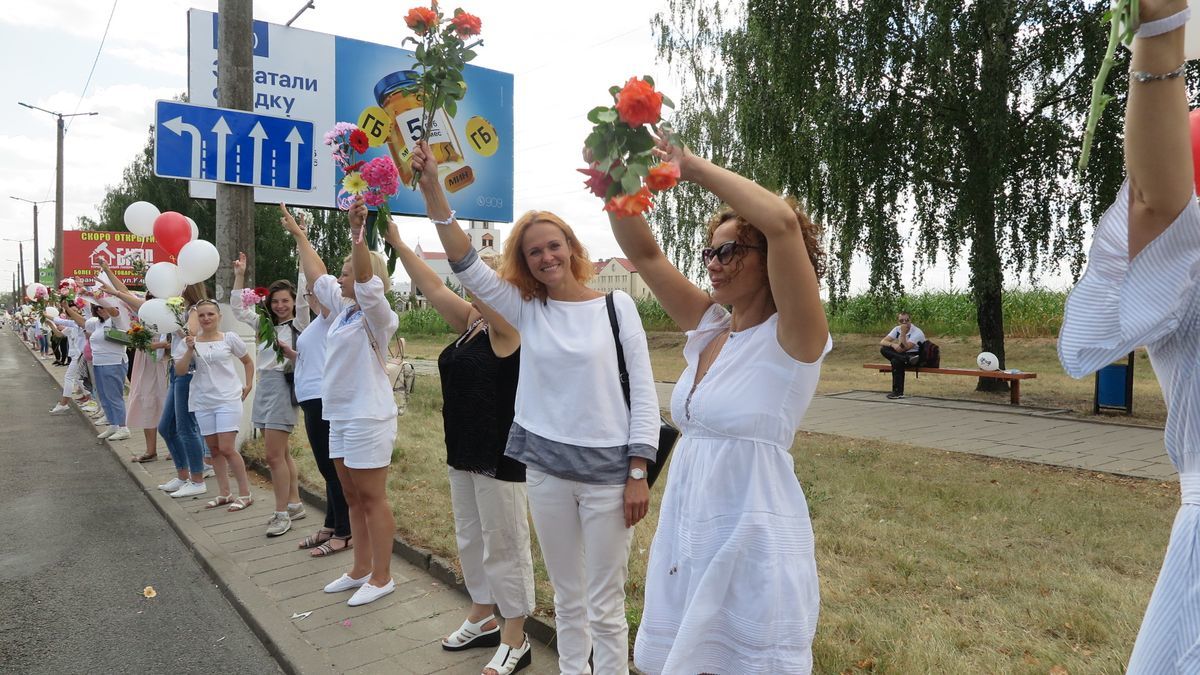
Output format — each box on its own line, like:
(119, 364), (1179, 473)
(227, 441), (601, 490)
(455, 255), (660, 448)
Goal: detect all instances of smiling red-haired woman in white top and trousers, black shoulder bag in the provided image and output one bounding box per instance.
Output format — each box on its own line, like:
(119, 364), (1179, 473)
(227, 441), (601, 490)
(413, 142), (659, 674)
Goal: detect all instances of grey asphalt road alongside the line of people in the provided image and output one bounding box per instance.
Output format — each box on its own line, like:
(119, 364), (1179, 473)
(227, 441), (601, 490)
(0, 329), (280, 674)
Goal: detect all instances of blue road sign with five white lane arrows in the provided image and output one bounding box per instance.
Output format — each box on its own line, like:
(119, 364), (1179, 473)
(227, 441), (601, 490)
(154, 101), (316, 190)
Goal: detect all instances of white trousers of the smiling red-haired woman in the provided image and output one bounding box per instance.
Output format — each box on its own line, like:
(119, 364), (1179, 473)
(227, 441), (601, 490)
(526, 468), (634, 675)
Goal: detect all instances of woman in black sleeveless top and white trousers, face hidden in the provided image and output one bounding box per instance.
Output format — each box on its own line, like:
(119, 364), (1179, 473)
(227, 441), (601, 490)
(385, 221), (534, 675)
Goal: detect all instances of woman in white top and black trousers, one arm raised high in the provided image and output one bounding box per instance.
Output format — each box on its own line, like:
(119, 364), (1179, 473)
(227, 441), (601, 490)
(280, 204), (350, 557)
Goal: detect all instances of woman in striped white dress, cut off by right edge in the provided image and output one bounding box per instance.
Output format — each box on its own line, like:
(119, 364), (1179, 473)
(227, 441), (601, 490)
(1058, 0), (1200, 675)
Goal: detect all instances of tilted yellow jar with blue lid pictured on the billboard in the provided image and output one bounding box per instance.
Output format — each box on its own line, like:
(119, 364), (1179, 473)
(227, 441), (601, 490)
(374, 71), (470, 189)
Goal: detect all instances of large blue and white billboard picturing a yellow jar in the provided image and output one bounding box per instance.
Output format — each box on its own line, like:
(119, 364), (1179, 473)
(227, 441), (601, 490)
(187, 10), (512, 222)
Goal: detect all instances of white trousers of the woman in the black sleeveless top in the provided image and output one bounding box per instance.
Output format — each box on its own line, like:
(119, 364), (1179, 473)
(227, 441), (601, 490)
(450, 468), (534, 619)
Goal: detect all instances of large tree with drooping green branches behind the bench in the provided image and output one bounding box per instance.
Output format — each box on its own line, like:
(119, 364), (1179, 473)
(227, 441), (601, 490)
(654, 0), (1128, 389)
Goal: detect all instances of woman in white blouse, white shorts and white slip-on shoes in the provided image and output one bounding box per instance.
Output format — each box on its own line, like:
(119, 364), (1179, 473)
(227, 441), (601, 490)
(300, 197), (400, 607)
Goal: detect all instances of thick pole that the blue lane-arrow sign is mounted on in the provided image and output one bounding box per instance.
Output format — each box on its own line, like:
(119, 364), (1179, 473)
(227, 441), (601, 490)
(216, 0), (254, 300)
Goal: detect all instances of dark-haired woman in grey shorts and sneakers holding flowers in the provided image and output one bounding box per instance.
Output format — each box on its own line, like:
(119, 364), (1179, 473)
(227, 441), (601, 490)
(229, 253), (307, 537)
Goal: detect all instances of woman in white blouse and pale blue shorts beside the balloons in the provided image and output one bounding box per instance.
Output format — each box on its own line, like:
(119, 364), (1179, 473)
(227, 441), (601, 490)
(175, 300), (254, 510)
